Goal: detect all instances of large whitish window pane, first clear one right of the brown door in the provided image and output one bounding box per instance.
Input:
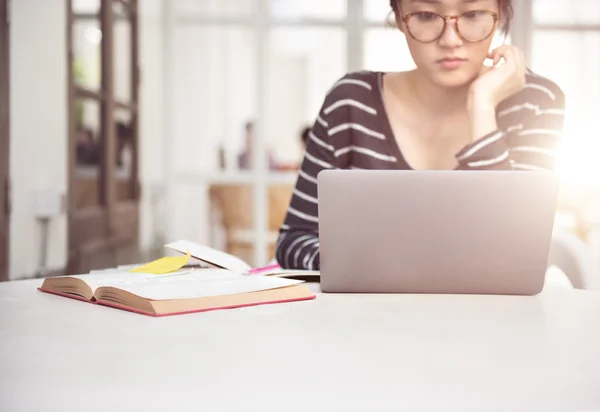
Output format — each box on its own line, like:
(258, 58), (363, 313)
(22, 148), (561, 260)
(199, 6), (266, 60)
(169, 25), (257, 172)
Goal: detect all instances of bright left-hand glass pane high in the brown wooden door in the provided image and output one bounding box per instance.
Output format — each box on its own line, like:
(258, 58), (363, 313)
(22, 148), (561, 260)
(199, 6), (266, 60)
(73, 20), (102, 91)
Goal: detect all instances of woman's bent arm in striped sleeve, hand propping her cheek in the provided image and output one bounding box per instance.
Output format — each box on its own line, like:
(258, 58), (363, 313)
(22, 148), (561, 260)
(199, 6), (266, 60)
(456, 45), (565, 170)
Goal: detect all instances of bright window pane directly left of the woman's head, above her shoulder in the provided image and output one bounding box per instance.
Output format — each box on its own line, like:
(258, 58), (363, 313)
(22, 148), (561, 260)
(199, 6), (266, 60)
(265, 28), (347, 169)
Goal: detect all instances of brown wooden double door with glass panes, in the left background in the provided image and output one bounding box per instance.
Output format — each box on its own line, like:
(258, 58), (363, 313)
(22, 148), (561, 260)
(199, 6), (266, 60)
(67, 0), (139, 273)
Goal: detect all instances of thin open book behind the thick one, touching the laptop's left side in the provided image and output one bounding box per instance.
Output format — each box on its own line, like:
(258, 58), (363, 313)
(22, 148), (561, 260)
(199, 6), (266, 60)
(165, 240), (319, 280)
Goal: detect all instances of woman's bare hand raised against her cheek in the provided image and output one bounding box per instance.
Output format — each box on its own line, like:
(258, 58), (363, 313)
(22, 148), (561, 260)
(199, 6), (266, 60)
(468, 45), (525, 113)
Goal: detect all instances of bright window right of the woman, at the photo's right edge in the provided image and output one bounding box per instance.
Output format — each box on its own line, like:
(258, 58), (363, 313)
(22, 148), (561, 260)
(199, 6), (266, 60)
(530, 0), (600, 184)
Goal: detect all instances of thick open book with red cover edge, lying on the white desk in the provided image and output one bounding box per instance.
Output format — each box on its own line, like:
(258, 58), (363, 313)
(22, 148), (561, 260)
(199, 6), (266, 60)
(39, 269), (315, 316)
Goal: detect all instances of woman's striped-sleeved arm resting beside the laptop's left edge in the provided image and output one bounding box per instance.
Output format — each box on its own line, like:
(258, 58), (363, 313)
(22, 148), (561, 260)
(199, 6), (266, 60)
(275, 110), (337, 270)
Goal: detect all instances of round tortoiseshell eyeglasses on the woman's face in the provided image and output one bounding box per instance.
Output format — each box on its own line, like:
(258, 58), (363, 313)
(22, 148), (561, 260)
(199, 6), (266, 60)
(402, 10), (498, 43)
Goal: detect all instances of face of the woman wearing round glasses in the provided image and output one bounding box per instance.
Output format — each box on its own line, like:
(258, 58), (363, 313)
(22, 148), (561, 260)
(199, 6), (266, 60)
(396, 0), (500, 87)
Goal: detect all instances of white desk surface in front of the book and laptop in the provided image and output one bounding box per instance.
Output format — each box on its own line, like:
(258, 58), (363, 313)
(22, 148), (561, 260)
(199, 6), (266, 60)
(0, 280), (600, 412)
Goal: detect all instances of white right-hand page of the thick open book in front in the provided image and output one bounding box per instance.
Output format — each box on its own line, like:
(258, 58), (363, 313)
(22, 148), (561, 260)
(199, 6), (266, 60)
(102, 269), (302, 300)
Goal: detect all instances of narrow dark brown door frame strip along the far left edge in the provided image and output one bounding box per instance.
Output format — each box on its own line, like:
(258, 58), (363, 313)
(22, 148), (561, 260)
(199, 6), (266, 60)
(0, 0), (11, 282)
